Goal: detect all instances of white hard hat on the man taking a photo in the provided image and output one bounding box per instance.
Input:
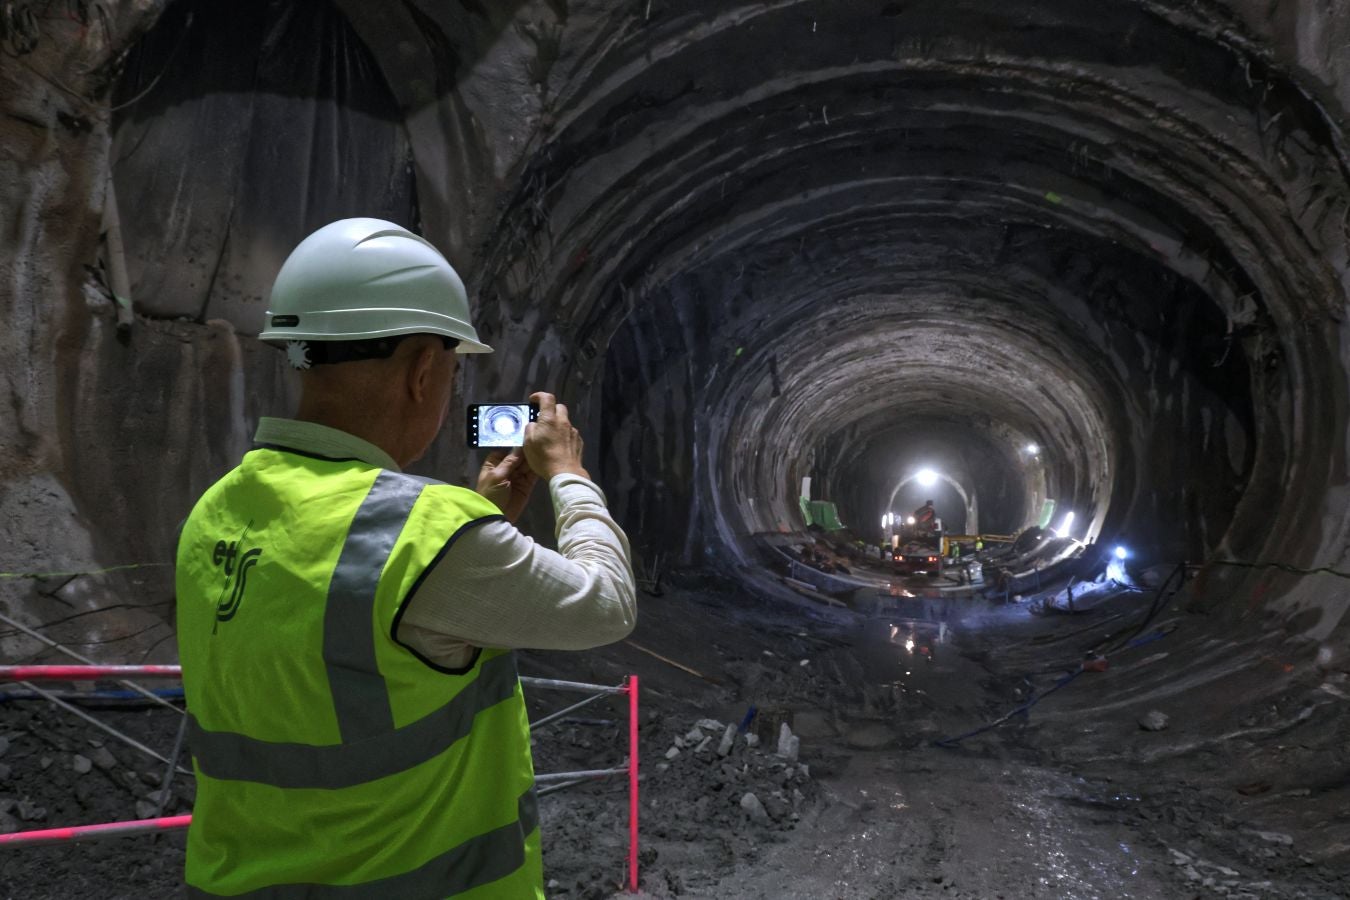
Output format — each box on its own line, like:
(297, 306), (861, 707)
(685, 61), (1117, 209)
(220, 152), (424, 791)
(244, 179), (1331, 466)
(259, 219), (493, 354)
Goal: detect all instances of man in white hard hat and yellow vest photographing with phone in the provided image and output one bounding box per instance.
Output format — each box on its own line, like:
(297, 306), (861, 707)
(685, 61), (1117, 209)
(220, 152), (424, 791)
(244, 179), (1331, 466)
(177, 219), (636, 900)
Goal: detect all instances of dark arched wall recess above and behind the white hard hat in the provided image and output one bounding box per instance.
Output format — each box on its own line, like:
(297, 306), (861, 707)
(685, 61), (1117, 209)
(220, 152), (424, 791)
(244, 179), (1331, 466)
(112, 0), (421, 335)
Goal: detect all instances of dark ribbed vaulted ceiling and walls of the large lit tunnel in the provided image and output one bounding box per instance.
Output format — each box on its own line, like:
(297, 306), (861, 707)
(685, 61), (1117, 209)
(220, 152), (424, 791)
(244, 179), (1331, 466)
(102, 0), (1350, 574)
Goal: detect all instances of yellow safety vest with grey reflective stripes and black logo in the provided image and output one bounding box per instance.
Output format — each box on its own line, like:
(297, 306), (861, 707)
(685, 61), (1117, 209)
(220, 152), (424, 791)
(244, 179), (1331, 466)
(177, 448), (544, 900)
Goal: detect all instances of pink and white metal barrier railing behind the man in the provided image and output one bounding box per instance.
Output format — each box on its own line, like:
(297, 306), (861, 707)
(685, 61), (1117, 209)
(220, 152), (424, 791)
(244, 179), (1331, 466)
(0, 665), (639, 893)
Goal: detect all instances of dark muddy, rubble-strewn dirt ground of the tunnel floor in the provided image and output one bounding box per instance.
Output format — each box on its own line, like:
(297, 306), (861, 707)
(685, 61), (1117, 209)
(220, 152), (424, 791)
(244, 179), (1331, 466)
(0, 576), (1350, 900)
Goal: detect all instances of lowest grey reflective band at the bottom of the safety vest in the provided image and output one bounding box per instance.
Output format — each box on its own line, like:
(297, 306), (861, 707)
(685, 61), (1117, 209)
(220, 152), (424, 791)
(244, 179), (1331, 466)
(186, 788), (539, 900)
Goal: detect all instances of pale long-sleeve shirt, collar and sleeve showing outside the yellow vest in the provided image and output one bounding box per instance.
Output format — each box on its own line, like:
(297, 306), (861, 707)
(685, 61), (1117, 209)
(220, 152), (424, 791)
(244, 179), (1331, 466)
(254, 418), (637, 668)
